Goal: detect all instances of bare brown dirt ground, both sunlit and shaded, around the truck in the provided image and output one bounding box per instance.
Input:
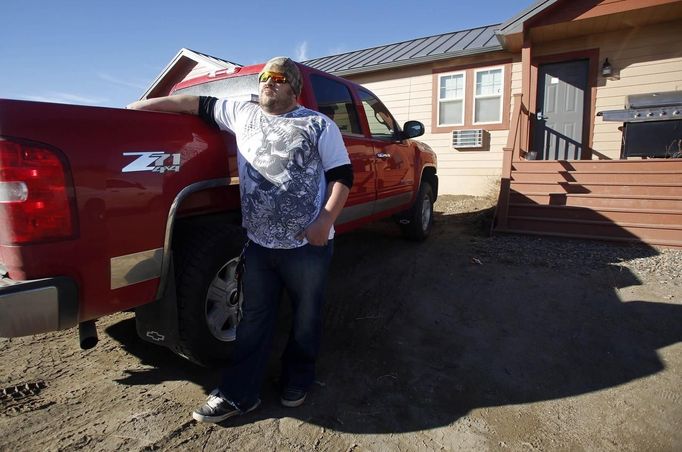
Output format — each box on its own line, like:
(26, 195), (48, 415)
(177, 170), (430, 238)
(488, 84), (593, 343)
(0, 196), (682, 451)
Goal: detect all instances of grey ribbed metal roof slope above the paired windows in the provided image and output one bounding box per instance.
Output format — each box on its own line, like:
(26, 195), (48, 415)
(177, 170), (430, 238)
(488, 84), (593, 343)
(302, 24), (502, 75)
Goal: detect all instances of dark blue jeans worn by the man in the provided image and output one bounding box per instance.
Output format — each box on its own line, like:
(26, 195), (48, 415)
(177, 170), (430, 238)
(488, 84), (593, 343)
(218, 240), (334, 410)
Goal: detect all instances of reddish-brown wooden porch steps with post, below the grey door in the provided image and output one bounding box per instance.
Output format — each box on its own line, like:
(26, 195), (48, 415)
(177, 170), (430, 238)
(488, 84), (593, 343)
(493, 94), (682, 248)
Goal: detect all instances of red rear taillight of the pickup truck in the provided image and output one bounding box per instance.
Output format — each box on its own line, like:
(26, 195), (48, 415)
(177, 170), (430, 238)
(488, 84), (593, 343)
(0, 138), (74, 245)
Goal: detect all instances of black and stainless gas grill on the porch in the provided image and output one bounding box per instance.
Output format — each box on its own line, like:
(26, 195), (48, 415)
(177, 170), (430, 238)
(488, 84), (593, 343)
(597, 91), (682, 159)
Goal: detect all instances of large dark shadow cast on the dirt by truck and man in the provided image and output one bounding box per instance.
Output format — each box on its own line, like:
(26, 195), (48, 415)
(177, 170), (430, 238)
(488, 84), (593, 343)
(107, 209), (682, 433)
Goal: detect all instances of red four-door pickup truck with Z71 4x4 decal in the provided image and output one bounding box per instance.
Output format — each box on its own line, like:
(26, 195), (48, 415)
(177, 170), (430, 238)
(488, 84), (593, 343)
(0, 61), (438, 364)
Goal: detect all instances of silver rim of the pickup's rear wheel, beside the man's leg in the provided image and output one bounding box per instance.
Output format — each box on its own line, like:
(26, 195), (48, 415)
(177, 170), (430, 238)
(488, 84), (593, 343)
(206, 258), (242, 342)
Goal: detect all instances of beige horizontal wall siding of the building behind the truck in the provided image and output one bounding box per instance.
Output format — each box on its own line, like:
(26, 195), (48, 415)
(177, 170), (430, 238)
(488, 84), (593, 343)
(348, 20), (682, 195)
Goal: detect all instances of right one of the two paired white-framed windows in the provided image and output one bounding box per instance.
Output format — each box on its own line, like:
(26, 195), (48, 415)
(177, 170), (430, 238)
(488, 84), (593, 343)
(473, 66), (504, 124)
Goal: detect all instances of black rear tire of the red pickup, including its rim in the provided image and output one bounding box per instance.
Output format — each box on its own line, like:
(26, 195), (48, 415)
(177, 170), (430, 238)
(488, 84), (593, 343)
(174, 225), (245, 367)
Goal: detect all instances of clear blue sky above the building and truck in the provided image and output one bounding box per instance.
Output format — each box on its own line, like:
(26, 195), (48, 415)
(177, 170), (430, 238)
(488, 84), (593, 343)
(0, 0), (533, 107)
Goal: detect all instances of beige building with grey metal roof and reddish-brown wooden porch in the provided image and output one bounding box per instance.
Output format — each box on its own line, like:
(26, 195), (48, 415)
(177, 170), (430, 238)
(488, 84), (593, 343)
(143, 0), (682, 247)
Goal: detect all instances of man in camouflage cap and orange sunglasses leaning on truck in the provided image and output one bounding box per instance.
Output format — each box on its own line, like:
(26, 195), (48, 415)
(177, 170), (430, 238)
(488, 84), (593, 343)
(128, 57), (353, 422)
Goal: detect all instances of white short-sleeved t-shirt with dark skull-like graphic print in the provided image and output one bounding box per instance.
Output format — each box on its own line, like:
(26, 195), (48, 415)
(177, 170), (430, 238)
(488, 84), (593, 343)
(214, 99), (350, 248)
